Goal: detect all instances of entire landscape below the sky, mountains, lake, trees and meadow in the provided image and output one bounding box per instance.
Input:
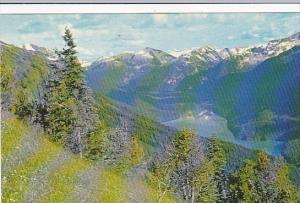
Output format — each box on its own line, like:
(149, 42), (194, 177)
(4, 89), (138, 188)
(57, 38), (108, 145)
(0, 28), (300, 203)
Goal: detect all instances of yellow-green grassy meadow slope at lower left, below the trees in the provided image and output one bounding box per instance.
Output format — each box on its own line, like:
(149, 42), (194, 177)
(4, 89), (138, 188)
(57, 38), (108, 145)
(2, 115), (176, 203)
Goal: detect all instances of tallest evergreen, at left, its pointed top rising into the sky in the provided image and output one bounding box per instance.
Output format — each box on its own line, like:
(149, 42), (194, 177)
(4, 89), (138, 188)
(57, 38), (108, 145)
(45, 28), (84, 148)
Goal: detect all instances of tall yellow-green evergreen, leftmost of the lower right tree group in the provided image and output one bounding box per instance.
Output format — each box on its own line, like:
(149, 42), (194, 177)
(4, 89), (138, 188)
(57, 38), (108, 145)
(153, 128), (201, 202)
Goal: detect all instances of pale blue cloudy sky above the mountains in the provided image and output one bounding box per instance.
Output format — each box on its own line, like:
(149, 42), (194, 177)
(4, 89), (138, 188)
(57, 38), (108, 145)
(0, 13), (300, 61)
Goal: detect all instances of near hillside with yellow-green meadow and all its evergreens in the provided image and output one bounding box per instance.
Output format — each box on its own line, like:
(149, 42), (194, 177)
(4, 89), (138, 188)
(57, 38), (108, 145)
(0, 28), (300, 203)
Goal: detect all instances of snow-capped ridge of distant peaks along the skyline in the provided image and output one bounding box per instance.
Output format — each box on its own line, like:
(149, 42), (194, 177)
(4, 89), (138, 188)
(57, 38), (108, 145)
(91, 32), (300, 71)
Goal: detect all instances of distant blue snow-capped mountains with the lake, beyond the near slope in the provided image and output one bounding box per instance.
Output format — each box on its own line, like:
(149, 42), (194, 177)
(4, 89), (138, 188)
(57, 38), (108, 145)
(86, 33), (300, 155)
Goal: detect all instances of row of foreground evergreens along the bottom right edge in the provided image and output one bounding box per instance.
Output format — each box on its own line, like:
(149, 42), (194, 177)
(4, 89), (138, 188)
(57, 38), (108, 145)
(152, 129), (300, 203)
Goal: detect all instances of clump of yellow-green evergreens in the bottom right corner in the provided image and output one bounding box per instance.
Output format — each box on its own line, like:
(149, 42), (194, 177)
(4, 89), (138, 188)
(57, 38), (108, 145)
(229, 152), (296, 203)
